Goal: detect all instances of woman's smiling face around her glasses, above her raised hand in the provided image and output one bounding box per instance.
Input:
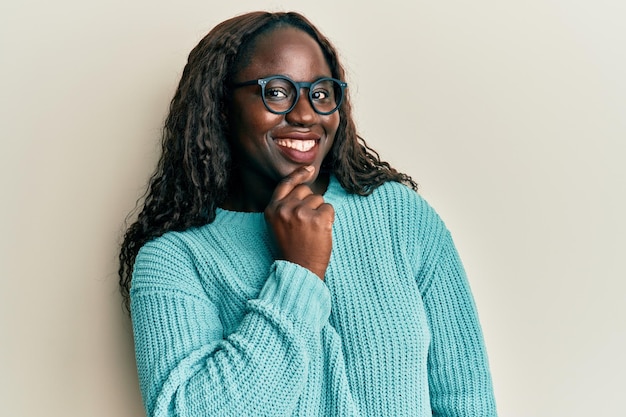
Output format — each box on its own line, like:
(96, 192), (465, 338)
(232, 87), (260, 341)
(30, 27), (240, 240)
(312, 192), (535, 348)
(228, 27), (339, 193)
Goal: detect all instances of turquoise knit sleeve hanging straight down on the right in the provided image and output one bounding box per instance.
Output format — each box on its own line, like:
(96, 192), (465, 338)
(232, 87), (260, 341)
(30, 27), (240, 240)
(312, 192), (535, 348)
(422, 231), (497, 417)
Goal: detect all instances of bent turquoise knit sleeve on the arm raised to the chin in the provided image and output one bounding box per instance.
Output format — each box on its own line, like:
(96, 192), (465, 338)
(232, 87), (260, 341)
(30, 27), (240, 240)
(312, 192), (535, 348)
(131, 236), (330, 417)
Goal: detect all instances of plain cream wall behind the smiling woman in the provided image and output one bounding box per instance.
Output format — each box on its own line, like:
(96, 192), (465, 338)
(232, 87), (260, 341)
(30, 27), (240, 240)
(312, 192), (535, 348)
(0, 0), (626, 417)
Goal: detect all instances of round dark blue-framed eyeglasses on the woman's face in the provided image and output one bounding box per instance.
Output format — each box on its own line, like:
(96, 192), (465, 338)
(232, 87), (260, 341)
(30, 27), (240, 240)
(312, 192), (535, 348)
(232, 75), (348, 115)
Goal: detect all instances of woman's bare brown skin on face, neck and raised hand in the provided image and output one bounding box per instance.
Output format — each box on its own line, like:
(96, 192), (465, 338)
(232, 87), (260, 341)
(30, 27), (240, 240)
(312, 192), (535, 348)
(224, 27), (339, 280)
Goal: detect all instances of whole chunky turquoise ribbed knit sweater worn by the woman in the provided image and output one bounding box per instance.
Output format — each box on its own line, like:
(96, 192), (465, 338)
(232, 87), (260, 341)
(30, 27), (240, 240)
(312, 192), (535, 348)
(131, 174), (496, 417)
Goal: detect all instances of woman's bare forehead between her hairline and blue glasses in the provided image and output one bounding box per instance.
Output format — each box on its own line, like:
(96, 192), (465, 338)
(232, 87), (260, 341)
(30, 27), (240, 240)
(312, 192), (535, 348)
(236, 27), (332, 81)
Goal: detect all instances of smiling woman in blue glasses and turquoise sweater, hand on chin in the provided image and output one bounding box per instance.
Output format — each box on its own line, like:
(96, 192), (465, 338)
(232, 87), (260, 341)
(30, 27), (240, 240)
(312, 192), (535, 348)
(120, 12), (495, 417)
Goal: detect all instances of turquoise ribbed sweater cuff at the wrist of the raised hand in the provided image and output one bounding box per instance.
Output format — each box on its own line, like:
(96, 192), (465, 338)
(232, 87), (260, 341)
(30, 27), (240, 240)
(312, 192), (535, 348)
(259, 261), (330, 331)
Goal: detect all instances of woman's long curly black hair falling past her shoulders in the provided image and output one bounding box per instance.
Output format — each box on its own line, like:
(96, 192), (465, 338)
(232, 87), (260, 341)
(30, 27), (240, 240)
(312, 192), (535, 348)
(118, 12), (417, 311)
